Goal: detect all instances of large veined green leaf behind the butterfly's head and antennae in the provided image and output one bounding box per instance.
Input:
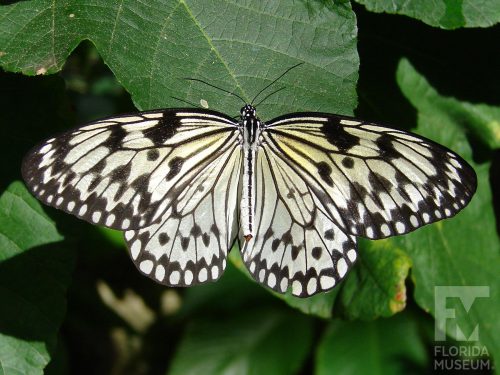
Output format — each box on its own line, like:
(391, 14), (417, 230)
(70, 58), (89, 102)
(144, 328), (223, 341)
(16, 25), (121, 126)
(0, 0), (359, 118)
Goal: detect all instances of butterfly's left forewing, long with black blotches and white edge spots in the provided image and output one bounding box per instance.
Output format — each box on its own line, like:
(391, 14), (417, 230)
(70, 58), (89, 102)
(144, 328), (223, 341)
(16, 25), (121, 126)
(22, 109), (239, 230)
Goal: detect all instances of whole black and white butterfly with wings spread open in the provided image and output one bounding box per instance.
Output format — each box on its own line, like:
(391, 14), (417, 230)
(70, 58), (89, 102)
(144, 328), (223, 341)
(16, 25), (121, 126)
(22, 74), (477, 297)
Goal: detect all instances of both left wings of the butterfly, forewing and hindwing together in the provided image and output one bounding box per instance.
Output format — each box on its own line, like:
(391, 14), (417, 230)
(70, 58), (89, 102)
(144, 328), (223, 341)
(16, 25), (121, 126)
(22, 109), (241, 286)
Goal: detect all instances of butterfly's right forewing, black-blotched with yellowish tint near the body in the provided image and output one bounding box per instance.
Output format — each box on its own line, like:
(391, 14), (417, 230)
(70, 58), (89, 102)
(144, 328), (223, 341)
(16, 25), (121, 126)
(261, 113), (477, 239)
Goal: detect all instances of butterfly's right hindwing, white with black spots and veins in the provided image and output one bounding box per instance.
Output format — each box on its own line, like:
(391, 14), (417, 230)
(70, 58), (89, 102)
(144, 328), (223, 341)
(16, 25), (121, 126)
(240, 145), (356, 297)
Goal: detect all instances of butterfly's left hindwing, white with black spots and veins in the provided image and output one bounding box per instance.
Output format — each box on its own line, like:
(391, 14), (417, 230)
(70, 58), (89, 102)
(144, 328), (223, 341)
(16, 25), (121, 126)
(125, 144), (241, 286)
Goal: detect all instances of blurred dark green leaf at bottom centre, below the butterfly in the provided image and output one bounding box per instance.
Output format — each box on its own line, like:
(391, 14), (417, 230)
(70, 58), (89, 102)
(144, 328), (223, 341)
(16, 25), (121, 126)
(169, 308), (312, 375)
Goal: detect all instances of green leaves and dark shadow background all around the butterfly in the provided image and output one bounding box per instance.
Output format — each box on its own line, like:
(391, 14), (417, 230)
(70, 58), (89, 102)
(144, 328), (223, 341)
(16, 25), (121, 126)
(0, 0), (500, 374)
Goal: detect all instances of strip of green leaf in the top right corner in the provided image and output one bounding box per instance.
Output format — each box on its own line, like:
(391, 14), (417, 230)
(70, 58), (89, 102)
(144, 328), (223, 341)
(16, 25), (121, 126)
(356, 0), (500, 29)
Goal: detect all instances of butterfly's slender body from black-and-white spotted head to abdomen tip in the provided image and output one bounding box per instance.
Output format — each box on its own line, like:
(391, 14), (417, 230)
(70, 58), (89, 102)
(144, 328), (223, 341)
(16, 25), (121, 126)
(240, 104), (261, 241)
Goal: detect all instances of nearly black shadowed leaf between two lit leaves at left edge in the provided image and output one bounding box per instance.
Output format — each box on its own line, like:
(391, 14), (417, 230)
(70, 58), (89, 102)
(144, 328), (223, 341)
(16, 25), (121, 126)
(0, 243), (75, 346)
